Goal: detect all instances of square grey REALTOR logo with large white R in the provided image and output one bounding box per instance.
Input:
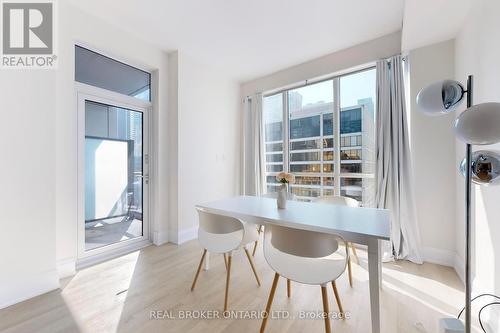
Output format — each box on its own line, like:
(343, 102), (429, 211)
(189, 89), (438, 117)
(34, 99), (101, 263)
(1, 1), (57, 68)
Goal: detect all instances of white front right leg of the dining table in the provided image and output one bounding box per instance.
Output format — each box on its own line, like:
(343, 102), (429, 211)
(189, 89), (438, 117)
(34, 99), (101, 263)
(368, 239), (382, 333)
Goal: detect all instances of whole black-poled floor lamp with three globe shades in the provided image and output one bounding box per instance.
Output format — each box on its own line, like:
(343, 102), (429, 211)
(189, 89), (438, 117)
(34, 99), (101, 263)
(417, 75), (500, 333)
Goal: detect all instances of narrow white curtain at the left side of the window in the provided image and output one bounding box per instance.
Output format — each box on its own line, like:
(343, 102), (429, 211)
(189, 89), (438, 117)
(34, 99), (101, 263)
(243, 93), (265, 195)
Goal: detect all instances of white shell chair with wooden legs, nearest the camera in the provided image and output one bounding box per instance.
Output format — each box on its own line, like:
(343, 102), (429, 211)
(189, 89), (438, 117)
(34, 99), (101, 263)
(260, 225), (349, 333)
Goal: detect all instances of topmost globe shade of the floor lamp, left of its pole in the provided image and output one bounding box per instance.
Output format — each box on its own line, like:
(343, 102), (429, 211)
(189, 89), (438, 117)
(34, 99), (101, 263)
(417, 80), (464, 115)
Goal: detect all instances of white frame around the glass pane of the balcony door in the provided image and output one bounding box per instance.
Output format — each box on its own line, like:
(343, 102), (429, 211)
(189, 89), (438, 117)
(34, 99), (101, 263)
(75, 82), (153, 262)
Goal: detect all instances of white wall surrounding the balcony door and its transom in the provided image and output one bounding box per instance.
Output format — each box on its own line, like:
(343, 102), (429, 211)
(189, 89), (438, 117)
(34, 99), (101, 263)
(54, 2), (169, 276)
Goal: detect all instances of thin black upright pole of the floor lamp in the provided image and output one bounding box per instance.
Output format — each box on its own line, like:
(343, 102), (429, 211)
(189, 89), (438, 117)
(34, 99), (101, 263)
(465, 75), (473, 333)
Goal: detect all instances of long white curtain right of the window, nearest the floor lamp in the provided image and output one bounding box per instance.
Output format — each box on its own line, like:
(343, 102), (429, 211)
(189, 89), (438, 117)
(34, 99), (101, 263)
(376, 55), (422, 263)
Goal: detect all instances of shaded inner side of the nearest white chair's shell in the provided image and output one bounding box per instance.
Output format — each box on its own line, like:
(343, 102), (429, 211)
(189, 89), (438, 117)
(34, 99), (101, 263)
(266, 225), (339, 258)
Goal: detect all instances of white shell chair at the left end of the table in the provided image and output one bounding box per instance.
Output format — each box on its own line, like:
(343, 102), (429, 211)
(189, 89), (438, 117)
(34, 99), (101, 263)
(191, 209), (260, 311)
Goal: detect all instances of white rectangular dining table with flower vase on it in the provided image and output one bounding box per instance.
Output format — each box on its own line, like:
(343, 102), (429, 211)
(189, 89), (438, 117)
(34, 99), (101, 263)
(196, 196), (390, 333)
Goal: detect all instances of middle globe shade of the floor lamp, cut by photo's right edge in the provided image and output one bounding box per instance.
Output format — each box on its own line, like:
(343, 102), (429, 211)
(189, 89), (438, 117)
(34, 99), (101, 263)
(455, 103), (500, 145)
